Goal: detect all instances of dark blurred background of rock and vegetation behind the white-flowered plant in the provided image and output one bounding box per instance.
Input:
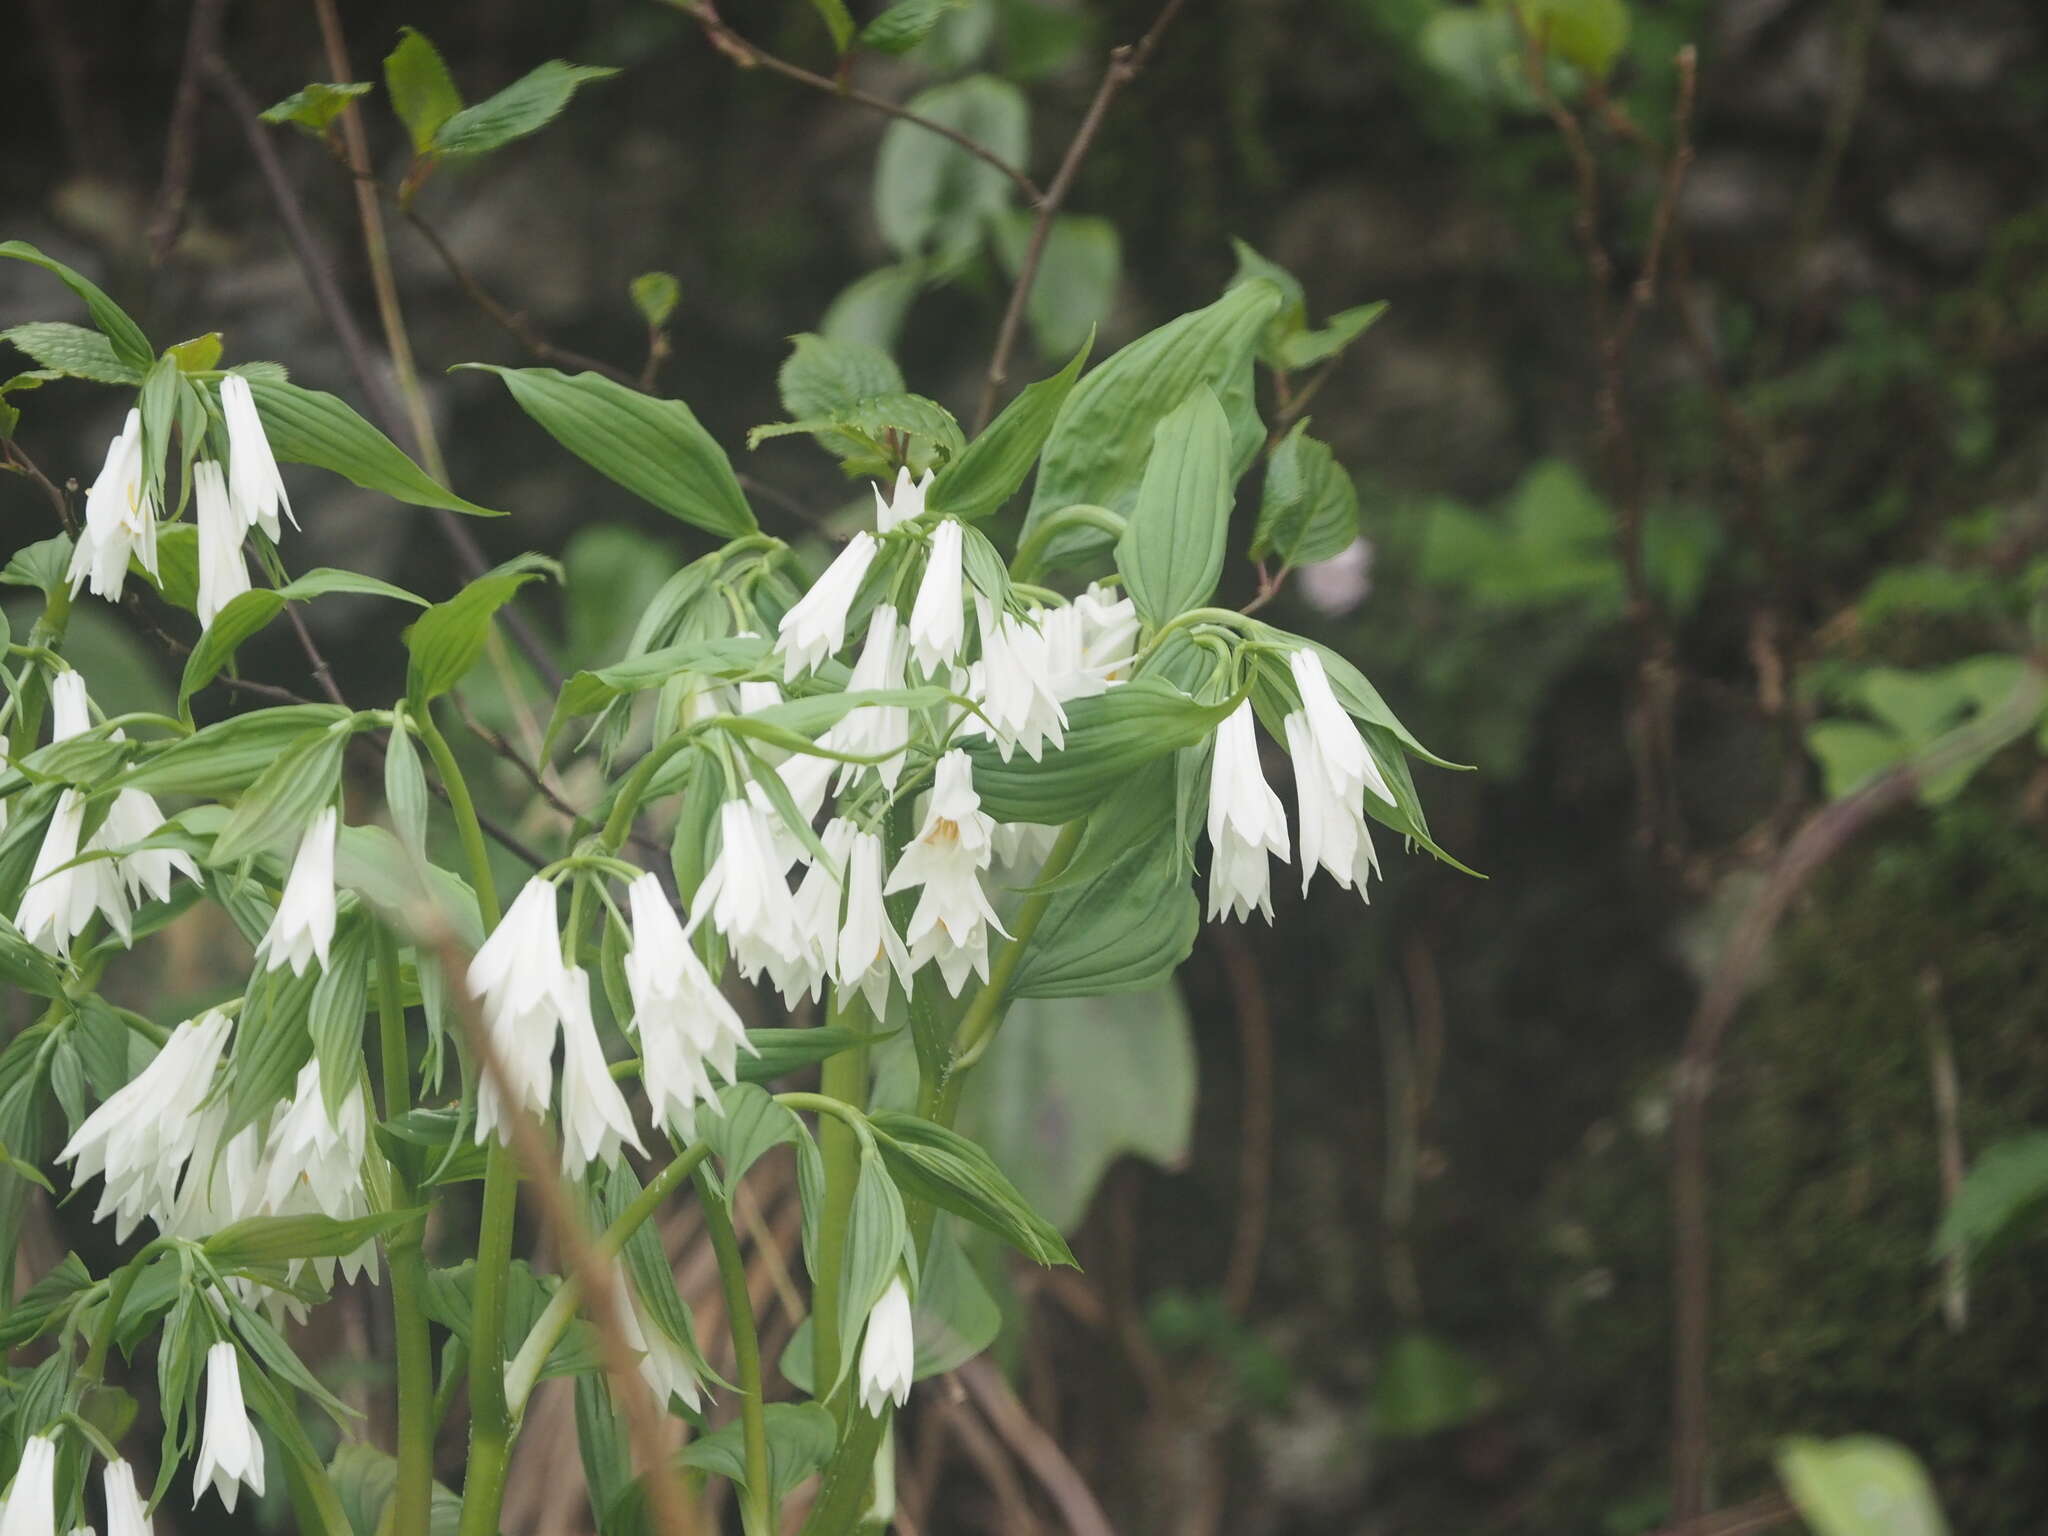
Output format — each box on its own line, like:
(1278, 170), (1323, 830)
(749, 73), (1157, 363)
(0, 0), (2048, 1536)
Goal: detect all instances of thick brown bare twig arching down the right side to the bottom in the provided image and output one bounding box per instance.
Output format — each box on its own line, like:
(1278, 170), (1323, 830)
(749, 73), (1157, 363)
(1671, 668), (2048, 1536)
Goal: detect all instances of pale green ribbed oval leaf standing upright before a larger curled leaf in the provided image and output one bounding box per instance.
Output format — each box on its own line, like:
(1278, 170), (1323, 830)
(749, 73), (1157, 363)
(1116, 385), (1233, 629)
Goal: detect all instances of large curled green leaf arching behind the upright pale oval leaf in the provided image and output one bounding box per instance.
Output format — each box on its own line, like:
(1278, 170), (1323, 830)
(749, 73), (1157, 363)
(1024, 281), (1280, 561)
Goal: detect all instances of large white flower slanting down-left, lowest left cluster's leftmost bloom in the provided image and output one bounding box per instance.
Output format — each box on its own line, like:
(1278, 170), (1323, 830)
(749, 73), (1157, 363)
(57, 1010), (233, 1243)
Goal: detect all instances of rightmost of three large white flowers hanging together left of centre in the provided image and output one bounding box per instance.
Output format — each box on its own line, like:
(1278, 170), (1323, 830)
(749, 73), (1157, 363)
(625, 874), (760, 1141)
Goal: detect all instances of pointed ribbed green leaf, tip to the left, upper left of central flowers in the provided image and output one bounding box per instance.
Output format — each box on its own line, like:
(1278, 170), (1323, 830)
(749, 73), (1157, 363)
(465, 362), (760, 539)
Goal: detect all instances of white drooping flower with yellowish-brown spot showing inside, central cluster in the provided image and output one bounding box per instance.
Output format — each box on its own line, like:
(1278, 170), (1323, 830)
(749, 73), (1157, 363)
(883, 750), (1008, 997)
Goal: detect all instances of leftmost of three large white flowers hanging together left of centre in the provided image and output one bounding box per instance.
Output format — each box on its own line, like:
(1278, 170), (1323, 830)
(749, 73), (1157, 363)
(469, 877), (569, 1143)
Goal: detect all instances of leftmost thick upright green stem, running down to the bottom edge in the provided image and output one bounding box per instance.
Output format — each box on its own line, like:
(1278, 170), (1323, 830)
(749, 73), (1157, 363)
(375, 924), (434, 1536)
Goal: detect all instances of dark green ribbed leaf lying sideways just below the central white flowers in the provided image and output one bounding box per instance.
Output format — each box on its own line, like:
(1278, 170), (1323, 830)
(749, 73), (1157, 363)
(967, 678), (1237, 825)
